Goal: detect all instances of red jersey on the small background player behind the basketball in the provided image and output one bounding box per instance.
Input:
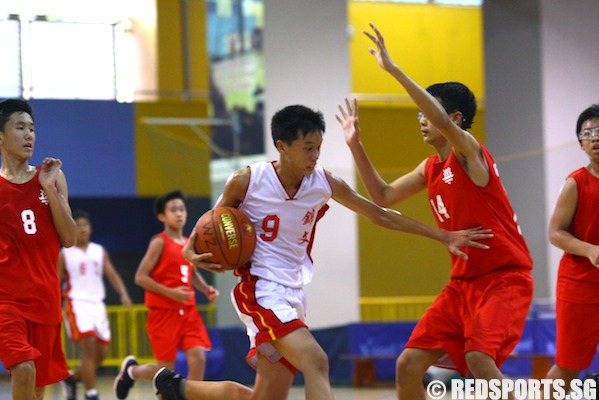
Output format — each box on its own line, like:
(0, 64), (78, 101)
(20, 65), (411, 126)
(145, 232), (196, 309)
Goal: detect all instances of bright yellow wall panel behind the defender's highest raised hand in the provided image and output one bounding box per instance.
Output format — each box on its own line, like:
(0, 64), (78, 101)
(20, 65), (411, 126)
(349, 2), (484, 98)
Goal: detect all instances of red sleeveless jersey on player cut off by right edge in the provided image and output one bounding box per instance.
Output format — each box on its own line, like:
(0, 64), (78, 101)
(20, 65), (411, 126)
(557, 168), (599, 303)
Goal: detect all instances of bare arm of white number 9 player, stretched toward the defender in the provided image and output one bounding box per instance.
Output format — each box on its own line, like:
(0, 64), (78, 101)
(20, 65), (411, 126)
(327, 172), (493, 259)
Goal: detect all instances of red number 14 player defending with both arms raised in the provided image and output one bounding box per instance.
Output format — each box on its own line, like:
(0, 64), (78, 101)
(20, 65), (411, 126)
(337, 24), (533, 400)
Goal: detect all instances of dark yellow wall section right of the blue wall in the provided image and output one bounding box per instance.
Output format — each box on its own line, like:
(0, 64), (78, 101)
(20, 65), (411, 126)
(135, 0), (211, 197)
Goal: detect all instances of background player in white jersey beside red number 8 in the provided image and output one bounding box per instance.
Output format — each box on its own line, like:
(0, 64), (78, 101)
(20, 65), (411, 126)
(58, 211), (131, 400)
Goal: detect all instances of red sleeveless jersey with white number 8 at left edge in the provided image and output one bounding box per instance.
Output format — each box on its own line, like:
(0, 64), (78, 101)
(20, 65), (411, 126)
(0, 167), (62, 324)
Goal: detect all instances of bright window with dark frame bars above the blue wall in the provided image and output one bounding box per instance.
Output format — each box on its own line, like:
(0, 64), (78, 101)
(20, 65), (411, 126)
(0, 16), (117, 100)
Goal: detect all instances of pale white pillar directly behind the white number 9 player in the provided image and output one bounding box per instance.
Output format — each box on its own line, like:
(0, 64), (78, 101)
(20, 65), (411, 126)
(264, 0), (359, 328)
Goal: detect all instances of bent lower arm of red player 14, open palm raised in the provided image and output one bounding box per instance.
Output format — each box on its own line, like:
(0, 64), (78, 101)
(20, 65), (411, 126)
(335, 99), (426, 207)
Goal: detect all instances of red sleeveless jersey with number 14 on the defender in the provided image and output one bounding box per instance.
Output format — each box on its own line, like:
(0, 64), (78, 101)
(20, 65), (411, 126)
(424, 145), (532, 278)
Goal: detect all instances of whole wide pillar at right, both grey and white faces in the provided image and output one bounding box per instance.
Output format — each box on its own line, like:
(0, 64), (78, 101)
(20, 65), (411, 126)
(483, 0), (599, 298)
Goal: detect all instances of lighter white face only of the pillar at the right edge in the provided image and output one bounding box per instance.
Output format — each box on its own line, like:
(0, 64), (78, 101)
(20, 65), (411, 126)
(540, 0), (599, 297)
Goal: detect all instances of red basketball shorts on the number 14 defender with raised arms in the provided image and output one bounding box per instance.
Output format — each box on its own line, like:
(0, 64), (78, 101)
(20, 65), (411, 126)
(406, 269), (533, 376)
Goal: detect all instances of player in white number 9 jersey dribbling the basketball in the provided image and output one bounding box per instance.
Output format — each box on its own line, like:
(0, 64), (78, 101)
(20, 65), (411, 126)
(142, 105), (492, 400)
